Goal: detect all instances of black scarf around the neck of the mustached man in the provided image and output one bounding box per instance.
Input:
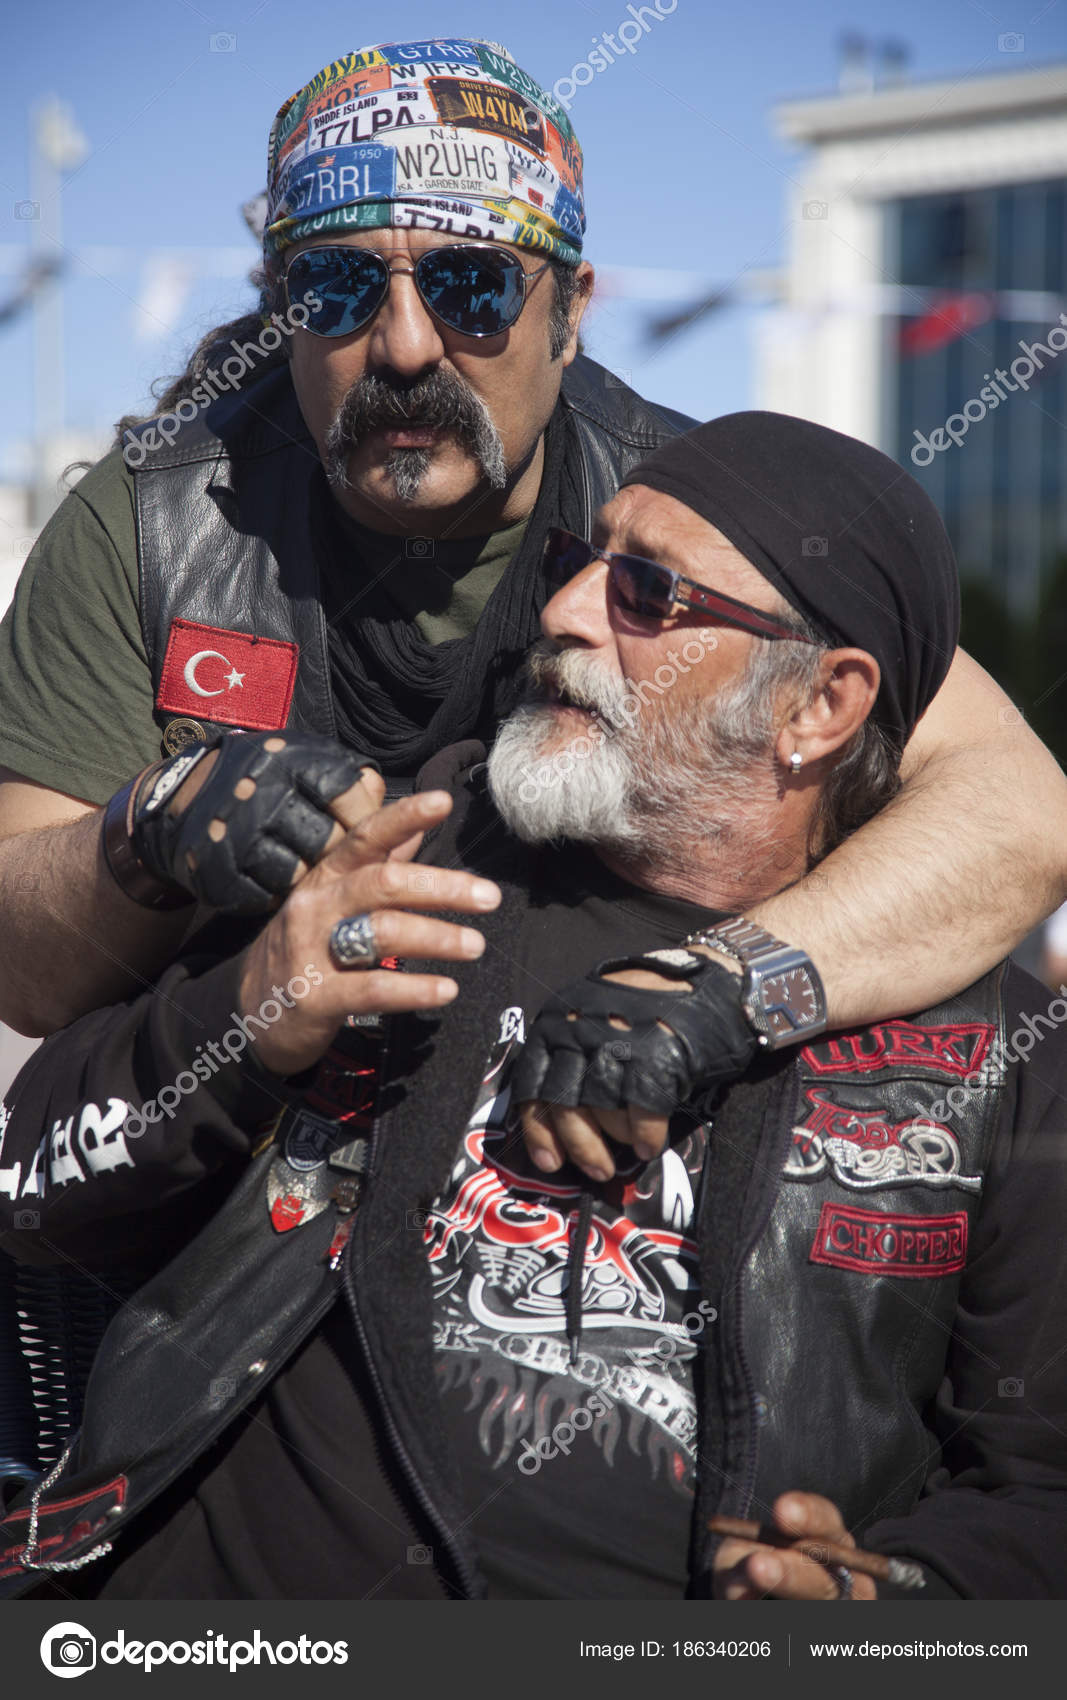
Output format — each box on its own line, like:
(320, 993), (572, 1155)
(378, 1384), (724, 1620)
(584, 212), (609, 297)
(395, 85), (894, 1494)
(314, 405), (584, 777)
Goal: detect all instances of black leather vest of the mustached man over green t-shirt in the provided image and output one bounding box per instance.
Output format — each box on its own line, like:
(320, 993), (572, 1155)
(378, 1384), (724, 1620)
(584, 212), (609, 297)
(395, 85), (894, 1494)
(126, 355), (695, 753)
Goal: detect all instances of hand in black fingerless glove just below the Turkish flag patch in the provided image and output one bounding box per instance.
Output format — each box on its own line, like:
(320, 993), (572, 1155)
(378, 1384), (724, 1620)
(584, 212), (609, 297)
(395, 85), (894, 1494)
(131, 733), (381, 915)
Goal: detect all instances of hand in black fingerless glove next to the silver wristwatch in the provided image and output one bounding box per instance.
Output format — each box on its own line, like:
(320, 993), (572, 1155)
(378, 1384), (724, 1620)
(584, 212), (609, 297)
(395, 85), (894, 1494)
(513, 952), (756, 1180)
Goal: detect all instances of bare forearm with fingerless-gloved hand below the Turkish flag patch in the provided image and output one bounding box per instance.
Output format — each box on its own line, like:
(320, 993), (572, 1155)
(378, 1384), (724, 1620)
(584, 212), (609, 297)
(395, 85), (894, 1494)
(0, 733), (382, 1037)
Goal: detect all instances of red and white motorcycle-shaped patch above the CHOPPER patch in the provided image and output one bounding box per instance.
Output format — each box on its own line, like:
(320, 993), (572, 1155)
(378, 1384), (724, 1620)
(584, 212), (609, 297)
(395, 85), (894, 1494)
(782, 1086), (982, 1192)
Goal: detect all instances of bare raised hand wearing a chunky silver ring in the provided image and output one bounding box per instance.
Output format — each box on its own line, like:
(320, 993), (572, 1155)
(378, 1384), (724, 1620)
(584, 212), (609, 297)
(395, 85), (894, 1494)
(240, 775), (500, 1074)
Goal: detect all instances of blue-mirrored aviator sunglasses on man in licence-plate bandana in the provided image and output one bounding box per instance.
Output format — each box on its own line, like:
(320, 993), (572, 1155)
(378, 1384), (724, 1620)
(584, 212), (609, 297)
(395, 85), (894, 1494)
(285, 243), (547, 337)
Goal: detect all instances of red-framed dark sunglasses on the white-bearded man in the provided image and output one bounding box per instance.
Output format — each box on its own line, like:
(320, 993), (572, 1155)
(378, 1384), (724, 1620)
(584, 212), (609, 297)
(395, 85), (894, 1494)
(544, 525), (812, 643)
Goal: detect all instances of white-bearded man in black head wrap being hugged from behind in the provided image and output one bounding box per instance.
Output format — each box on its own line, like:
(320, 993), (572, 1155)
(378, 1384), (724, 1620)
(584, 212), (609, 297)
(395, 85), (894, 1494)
(0, 415), (1067, 1600)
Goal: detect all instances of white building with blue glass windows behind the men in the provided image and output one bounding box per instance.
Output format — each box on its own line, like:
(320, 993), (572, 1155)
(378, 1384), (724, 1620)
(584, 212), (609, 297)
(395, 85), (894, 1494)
(758, 61), (1067, 607)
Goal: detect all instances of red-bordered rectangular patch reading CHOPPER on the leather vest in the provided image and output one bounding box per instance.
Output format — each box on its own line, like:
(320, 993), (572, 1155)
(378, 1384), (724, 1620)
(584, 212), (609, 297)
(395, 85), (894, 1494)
(809, 1204), (967, 1277)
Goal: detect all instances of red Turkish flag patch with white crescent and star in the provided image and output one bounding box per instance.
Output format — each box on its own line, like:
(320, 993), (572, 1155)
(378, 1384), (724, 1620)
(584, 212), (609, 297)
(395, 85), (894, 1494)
(156, 621), (301, 733)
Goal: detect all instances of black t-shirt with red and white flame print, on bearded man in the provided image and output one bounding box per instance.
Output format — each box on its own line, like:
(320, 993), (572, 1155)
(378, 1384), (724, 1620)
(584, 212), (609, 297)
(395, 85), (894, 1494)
(426, 852), (714, 1600)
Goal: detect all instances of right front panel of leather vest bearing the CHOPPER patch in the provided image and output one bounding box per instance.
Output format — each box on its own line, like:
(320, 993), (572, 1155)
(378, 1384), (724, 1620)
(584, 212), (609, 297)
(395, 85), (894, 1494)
(737, 967), (1006, 1540)
